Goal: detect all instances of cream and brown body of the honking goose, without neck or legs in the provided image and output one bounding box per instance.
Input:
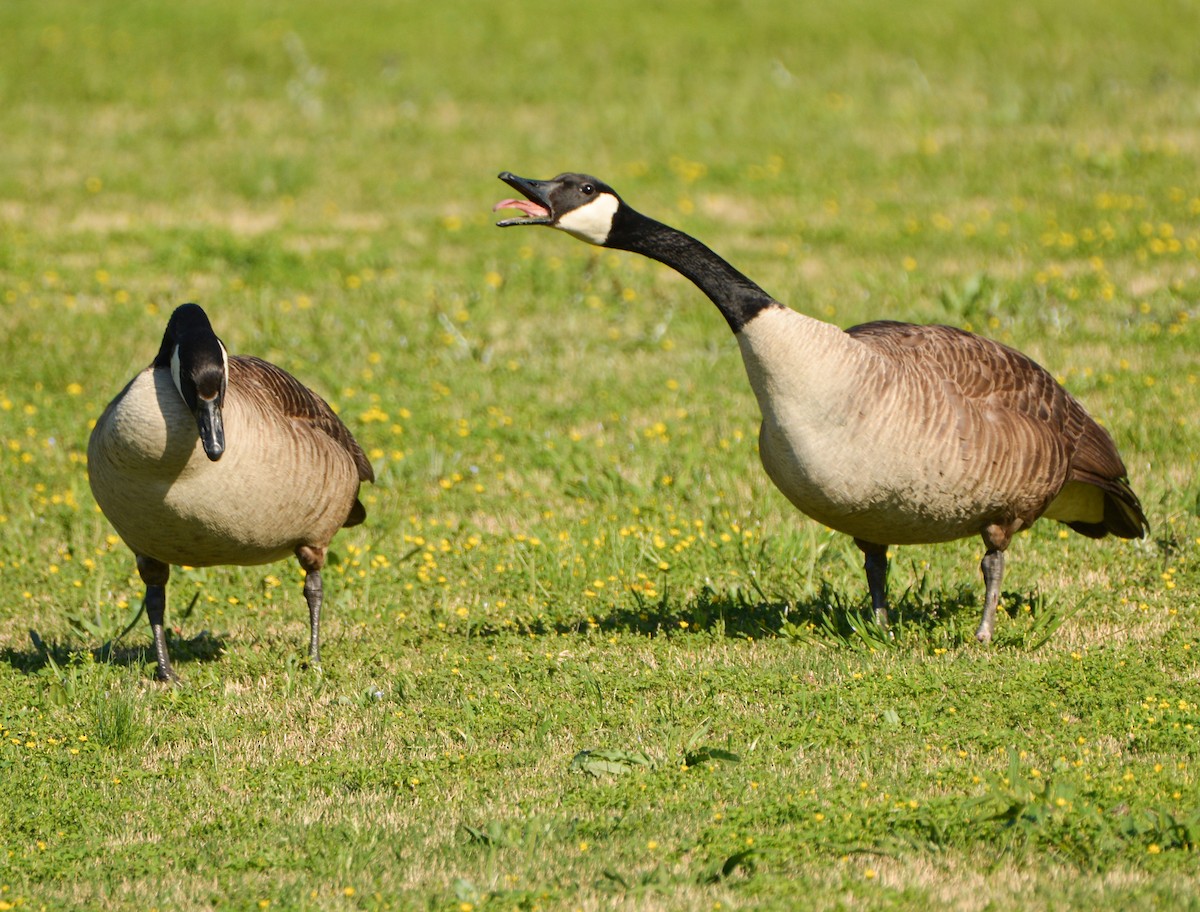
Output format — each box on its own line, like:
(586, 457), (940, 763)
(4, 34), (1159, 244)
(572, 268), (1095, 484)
(738, 307), (1142, 545)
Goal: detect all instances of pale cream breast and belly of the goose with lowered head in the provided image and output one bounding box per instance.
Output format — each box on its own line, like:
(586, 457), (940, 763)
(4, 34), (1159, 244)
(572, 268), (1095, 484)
(88, 372), (358, 566)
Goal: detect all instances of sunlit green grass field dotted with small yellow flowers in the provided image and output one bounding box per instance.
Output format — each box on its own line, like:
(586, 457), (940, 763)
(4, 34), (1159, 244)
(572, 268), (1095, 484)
(0, 0), (1200, 912)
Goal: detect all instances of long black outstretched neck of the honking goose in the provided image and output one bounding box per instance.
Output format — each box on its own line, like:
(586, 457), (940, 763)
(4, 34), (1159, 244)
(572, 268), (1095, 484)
(605, 205), (778, 332)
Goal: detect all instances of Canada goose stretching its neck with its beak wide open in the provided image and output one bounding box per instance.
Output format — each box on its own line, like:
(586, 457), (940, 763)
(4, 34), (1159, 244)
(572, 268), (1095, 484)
(493, 172), (1148, 643)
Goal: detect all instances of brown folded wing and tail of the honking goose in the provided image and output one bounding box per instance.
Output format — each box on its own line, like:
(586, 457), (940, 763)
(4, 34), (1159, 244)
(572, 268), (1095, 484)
(846, 320), (1150, 538)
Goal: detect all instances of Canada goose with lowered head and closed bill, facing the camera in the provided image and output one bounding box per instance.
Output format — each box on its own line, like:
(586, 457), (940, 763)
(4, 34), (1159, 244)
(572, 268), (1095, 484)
(88, 304), (374, 680)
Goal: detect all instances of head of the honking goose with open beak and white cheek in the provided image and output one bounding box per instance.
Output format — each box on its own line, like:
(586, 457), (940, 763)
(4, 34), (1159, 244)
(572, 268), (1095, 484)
(492, 172), (625, 247)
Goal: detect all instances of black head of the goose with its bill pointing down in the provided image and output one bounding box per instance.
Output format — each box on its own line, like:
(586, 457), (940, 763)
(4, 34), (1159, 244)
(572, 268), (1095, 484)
(154, 304), (229, 462)
